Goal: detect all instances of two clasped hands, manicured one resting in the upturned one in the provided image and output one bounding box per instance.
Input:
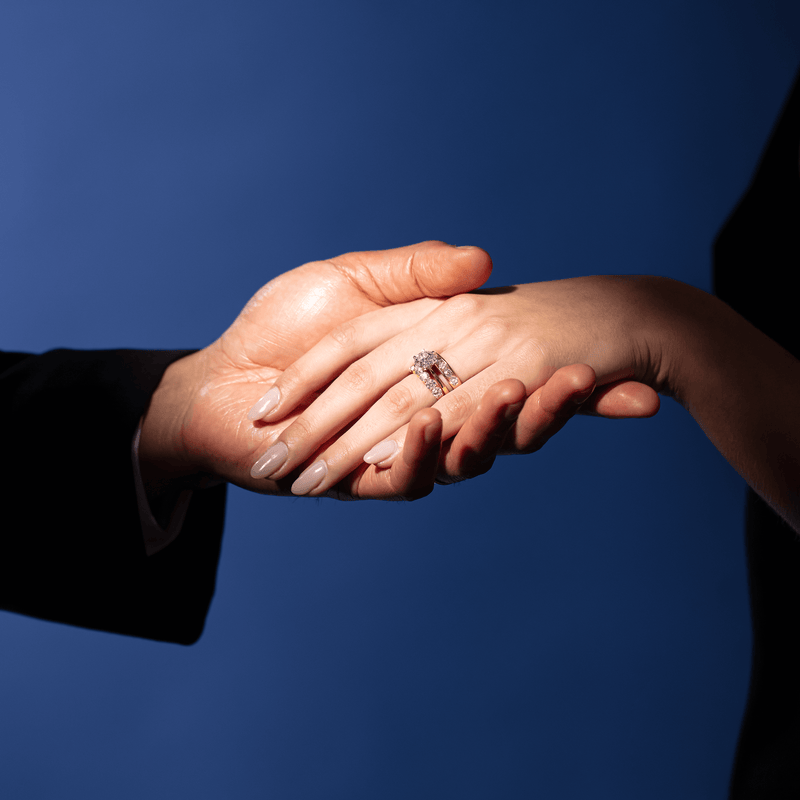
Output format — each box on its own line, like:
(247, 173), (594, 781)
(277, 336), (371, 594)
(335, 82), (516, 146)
(140, 242), (660, 499)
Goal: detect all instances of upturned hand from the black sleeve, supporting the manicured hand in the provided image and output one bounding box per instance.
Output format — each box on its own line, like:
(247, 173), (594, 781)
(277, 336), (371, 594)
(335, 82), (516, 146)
(139, 242), (657, 507)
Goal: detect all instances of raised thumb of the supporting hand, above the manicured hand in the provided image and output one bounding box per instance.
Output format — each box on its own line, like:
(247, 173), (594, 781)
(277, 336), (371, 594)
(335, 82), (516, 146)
(331, 241), (492, 306)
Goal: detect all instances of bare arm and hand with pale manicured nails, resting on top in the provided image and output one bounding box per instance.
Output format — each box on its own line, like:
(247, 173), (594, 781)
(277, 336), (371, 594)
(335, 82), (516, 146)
(253, 276), (800, 530)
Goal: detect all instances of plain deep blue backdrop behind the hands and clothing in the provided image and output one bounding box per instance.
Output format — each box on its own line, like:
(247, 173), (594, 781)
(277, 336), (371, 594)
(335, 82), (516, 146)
(0, 0), (800, 800)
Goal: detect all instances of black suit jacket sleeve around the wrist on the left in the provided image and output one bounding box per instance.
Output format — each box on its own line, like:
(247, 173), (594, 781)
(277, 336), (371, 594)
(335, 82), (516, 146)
(0, 350), (225, 644)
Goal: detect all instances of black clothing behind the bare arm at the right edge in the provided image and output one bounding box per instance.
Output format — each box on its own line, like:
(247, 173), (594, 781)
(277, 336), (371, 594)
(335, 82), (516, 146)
(714, 70), (800, 800)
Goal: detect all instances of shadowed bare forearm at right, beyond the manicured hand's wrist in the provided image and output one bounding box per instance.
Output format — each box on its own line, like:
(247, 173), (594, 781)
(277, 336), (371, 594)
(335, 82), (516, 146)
(664, 281), (800, 531)
